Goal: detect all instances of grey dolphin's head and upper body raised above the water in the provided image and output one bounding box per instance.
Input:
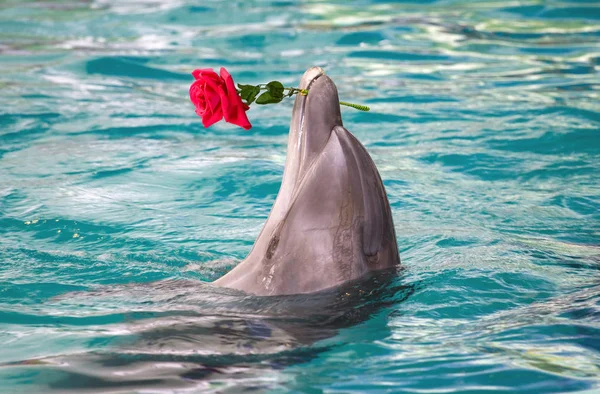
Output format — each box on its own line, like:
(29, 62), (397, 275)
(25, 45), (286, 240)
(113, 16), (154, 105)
(214, 67), (400, 295)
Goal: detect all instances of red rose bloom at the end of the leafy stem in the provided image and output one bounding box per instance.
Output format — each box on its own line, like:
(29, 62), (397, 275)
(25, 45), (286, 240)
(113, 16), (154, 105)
(190, 68), (252, 130)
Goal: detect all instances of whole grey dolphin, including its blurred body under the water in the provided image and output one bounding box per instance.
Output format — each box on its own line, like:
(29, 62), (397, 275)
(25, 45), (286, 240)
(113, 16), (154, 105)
(0, 67), (404, 391)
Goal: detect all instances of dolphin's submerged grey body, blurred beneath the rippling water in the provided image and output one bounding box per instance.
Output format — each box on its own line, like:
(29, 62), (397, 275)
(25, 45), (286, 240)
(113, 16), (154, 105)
(3, 270), (414, 391)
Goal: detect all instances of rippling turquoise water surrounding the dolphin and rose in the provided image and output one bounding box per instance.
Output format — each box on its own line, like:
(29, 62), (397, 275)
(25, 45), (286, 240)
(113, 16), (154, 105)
(0, 0), (600, 393)
